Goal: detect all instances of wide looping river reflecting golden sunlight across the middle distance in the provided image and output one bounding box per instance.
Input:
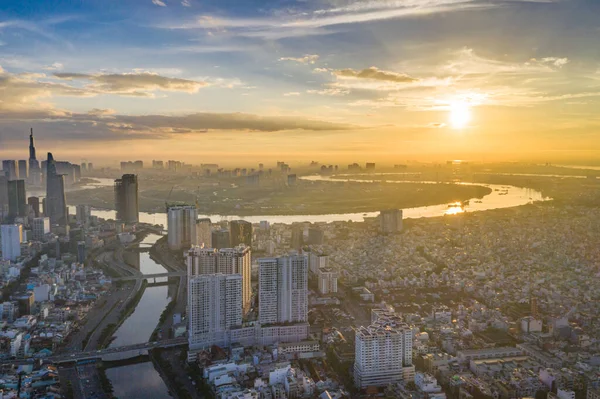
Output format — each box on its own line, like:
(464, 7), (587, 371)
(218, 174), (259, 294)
(77, 173), (549, 226)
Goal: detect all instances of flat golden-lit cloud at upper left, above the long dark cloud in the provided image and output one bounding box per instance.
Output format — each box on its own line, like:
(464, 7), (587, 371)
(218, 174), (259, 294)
(54, 72), (208, 97)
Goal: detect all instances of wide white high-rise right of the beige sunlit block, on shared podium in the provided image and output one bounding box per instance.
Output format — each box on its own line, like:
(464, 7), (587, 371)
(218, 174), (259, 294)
(258, 255), (308, 324)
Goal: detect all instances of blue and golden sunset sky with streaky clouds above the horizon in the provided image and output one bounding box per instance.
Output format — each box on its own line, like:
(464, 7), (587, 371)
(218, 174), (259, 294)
(0, 0), (600, 164)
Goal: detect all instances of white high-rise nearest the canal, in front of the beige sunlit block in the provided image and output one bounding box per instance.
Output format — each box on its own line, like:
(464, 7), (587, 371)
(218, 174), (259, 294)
(188, 274), (242, 350)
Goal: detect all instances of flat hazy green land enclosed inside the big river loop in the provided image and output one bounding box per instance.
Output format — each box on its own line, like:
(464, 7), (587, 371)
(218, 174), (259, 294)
(64, 179), (491, 217)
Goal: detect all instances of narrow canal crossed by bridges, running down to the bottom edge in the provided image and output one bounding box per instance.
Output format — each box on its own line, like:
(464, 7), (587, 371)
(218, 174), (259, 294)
(106, 234), (171, 399)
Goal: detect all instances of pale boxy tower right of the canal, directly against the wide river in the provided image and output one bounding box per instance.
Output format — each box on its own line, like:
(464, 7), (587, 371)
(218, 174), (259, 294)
(167, 205), (198, 250)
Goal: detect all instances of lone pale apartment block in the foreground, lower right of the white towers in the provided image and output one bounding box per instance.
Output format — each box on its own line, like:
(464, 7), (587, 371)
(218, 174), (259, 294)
(354, 312), (413, 388)
